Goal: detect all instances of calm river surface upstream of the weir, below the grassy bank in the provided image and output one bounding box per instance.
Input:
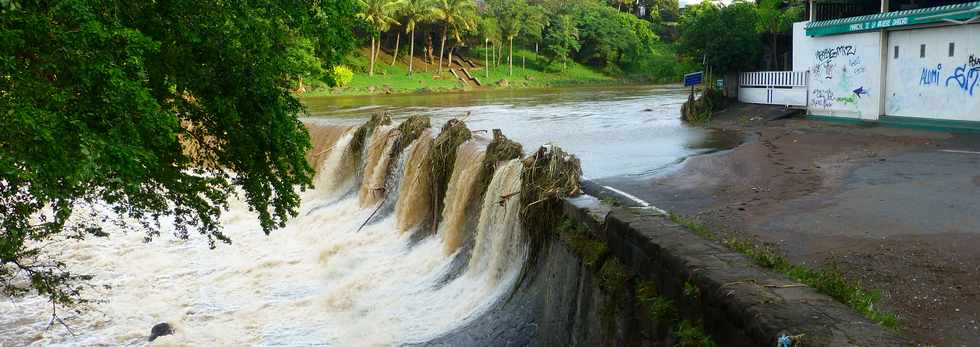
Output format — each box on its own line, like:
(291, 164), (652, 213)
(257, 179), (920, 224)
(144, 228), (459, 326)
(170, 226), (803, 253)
(303, 86), (739, 179)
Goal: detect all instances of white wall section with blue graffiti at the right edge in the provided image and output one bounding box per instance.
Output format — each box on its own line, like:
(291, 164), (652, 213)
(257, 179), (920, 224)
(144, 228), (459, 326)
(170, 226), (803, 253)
(885, 24), (980, 121)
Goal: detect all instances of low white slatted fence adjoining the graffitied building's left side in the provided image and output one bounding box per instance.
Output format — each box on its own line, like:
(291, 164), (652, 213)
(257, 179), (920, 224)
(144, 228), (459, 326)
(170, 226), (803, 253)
(738, 71), (810, 107)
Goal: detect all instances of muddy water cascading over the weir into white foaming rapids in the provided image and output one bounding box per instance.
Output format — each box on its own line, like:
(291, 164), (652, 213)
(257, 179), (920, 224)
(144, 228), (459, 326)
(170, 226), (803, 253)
(0, 115), (544, 346)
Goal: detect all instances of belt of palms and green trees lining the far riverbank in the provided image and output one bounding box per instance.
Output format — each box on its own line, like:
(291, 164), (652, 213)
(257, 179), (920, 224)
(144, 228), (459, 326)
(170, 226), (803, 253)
(326, 0), (803, 87)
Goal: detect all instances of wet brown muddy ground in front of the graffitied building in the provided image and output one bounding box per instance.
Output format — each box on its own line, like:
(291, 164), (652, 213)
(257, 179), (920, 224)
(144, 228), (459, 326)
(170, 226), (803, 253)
(600, 115), (980, 346)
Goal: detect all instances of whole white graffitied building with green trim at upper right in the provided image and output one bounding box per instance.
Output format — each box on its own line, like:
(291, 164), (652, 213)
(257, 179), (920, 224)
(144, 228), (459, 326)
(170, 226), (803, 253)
(740, 0), (980, 128)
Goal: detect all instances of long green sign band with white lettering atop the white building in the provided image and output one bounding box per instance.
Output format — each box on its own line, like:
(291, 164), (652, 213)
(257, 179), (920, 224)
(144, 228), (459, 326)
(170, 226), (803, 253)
(806, 1), (980, 36)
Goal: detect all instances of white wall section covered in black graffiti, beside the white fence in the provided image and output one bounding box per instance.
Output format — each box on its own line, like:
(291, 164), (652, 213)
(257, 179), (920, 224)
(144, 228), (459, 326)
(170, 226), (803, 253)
(793, 22), (883, 120)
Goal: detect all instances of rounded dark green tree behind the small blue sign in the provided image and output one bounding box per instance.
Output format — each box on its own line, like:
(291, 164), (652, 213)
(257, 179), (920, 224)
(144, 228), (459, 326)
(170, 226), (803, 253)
(680, 1), (762, 74)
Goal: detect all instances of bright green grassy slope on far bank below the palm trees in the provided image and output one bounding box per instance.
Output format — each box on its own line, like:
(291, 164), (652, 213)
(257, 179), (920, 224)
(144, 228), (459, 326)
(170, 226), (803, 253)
(305, 47), (618, 96)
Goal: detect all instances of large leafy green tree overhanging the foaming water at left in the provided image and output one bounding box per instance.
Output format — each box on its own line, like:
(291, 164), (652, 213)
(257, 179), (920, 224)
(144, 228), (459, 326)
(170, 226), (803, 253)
(0, 0), (357, 306)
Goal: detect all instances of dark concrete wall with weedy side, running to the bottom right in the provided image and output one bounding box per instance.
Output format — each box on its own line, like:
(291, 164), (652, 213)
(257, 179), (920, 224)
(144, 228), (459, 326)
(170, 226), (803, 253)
(552, 197), (917, 346)
